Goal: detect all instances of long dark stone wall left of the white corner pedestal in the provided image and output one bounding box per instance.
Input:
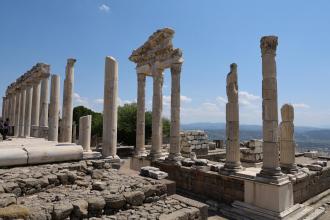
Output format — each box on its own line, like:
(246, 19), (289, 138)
(152, 161), (244, 203)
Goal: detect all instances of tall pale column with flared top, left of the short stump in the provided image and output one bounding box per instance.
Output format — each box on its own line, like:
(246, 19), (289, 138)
(61, 58), (76, 142)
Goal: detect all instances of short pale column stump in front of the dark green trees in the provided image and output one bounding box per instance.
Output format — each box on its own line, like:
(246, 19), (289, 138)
(79, 115), (92, 152)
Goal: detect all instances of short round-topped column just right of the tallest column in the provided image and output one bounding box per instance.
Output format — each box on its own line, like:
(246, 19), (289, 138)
(279, 104), (298, 174)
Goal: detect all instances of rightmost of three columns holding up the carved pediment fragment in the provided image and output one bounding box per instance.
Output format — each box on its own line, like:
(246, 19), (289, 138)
(169, 63), (182, 160)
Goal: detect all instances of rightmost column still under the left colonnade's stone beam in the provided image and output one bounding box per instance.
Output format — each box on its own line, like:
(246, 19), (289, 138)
(38, 77), (49, 138)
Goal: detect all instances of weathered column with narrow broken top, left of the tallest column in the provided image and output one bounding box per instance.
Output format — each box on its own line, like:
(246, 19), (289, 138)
(222, 63), (242, 173)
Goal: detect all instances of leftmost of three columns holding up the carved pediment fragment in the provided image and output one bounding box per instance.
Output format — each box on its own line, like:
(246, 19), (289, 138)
(135, 73), (146, 156)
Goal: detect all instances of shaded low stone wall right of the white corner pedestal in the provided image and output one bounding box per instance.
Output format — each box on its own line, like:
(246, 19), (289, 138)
(293, 167), (330, 203)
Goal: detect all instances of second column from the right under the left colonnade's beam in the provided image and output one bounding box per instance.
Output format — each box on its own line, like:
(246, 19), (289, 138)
(31, 80), (40, 137)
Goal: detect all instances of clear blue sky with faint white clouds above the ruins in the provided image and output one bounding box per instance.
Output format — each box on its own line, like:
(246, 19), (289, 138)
(0, 0), (330, 127)
